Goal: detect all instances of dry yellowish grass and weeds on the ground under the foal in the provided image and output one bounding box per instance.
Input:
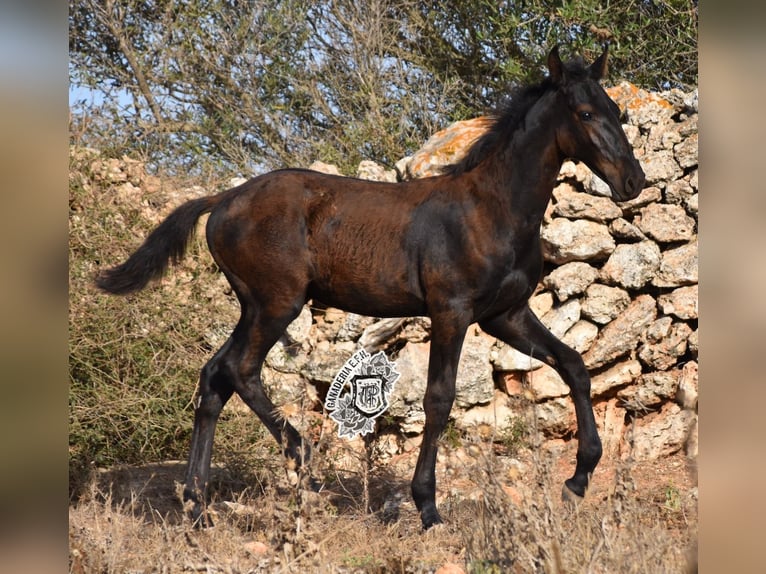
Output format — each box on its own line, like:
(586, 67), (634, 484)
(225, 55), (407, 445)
(69, 430), (696, 574)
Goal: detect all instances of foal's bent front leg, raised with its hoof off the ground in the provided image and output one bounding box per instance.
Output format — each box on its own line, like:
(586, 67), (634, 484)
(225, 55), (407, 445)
(479, 305), (602, 499)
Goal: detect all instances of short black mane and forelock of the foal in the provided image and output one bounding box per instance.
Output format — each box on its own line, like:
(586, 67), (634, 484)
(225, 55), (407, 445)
(441, 58), (588, 175)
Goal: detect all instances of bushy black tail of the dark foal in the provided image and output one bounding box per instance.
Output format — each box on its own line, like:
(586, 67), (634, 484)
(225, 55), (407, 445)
(95, 195), (220, 295)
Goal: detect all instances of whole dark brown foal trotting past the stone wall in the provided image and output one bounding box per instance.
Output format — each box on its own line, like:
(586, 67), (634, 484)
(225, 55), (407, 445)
(96, 48), (644, 528)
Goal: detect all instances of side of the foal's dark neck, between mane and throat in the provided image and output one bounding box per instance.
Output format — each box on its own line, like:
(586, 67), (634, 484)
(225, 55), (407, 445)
(489, 99), (563, 233)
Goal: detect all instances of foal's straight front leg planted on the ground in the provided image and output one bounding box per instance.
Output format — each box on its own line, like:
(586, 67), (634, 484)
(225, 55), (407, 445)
(411, 318), (466, 529)
